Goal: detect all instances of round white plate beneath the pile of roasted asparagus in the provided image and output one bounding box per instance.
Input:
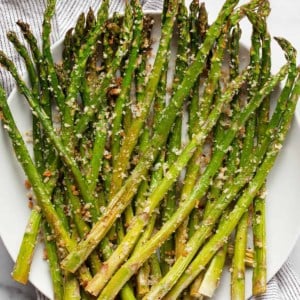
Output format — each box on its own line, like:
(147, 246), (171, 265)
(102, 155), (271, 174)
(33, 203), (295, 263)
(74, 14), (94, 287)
(0, 0), (300, 300)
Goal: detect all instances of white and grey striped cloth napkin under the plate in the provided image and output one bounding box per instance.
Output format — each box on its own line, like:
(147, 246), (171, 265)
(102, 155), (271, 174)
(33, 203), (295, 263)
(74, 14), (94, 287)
(0, 0), (300, 300)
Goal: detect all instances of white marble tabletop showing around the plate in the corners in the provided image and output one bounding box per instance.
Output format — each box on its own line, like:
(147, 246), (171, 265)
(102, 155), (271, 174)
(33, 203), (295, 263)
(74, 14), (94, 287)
(0, 0), (300, 300)
